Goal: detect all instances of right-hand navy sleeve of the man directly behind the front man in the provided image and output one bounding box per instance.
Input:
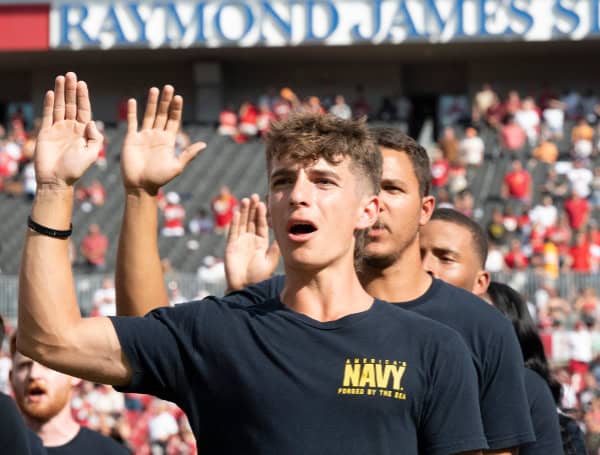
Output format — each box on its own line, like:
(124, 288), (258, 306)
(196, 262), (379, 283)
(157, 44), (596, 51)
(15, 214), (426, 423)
(480, 320), (535, 449)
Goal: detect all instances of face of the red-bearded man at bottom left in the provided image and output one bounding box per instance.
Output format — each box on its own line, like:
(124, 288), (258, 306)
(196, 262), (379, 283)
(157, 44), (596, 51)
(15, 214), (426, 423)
(10, 352), (78, 423)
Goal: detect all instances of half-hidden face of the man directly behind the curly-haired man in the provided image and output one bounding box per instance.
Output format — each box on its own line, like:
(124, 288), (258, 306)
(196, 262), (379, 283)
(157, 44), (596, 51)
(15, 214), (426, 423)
(364, 148), (434, 268)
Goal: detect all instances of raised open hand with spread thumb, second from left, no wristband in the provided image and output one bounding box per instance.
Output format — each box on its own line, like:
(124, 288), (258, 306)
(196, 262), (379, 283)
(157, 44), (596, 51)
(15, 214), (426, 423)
(121, 85), (206, 194)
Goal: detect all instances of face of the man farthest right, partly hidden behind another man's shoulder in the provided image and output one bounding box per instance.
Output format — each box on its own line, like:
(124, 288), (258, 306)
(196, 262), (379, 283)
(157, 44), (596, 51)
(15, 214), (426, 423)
(419, 220), (487, 295)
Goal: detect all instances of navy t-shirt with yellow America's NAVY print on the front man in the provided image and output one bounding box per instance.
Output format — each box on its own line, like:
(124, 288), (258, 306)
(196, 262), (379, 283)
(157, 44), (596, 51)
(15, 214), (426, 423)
(112, 296), (486, 455)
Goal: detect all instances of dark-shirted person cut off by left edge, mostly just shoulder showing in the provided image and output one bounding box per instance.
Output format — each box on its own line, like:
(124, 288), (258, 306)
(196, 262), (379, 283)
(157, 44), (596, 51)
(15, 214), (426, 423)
(0, 316), (46, 455)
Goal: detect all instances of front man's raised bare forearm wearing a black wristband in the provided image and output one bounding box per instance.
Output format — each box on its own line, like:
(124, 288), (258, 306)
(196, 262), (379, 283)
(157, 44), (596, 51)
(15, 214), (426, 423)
(19, 186), (81, 361)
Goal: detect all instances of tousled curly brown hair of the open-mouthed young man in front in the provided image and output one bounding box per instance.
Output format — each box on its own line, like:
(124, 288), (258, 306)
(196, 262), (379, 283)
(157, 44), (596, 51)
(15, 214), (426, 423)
(265, 113), (382, 194)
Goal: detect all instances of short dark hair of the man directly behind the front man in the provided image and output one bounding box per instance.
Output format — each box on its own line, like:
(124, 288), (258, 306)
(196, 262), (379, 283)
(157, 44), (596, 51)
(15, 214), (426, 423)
(371, 126), (431, 197)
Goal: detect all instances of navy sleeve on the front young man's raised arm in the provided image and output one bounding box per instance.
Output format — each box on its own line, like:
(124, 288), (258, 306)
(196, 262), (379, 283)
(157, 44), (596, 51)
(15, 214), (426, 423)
(111, 298), (209, 401)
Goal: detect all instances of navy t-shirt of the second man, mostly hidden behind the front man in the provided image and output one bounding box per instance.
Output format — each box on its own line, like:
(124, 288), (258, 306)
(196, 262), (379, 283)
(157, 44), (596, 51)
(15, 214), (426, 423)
(233, 275), (535, 449)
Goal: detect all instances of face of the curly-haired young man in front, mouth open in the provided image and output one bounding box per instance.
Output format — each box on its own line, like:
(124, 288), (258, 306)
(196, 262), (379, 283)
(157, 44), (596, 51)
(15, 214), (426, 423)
(268, 158), (378, 270)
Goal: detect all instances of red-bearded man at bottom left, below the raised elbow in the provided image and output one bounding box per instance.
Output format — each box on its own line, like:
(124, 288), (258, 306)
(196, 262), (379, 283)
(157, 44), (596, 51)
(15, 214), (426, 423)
(10, 336), (129, 455)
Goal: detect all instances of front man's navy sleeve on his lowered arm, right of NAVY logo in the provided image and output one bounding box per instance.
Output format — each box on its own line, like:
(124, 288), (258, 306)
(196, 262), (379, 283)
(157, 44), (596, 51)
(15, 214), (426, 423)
(419, 331), (487, 455)
